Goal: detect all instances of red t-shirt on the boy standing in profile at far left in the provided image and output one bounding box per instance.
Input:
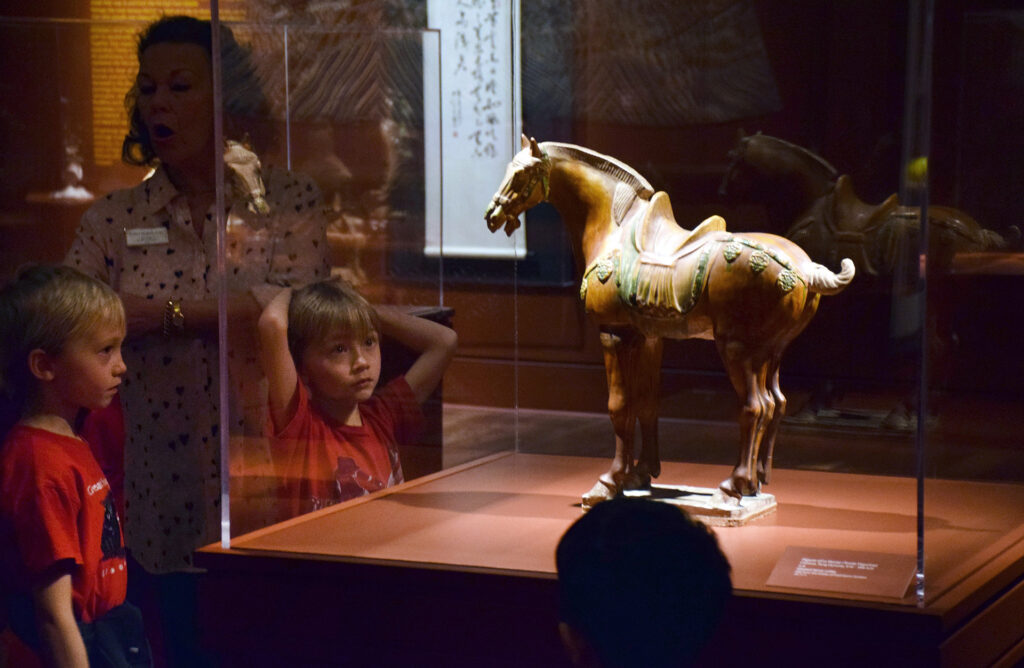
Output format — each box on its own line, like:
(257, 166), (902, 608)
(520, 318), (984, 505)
(0, 425), (128, 622)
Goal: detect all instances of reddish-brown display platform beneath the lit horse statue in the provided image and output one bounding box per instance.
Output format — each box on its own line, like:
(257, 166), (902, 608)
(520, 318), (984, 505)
(197, 453), (1024, 666)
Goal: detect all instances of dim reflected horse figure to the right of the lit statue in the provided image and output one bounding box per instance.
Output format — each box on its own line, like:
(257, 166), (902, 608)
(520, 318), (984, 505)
(719, 132), (1019, 276)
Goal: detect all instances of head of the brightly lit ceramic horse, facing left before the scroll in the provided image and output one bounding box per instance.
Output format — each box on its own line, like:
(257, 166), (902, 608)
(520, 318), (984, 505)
(483, 134), (551, 237)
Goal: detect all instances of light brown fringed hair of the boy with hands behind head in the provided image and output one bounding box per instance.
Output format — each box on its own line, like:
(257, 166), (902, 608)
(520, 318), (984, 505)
(288, 279), (380, 366)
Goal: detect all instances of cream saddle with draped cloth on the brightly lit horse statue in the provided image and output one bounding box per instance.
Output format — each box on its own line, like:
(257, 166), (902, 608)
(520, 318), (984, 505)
(581, 192), (728, 318)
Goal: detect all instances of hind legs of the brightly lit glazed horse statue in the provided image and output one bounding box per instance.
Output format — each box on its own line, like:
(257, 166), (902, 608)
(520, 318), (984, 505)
(716, 338), (775, 499)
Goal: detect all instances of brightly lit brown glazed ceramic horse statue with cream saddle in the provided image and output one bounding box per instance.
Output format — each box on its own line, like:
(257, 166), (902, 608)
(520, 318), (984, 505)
(485, 136), (855, 506)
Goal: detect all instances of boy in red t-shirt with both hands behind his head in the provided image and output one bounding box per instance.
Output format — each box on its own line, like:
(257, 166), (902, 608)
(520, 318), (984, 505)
(259, 279), (457, 515)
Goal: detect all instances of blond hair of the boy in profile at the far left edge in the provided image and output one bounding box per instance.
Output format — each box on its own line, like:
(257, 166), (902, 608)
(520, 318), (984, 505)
(0, 264), (125, 436)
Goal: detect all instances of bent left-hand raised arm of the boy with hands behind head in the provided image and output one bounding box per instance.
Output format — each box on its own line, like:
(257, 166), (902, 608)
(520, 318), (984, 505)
(258, 288), (298, 431)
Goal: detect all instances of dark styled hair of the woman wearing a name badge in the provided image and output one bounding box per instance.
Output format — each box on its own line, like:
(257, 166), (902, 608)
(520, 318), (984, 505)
(121, 16), (267, 166)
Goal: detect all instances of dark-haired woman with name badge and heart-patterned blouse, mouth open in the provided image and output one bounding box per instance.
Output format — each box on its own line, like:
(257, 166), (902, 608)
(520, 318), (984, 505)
(66, 16), (329, 665)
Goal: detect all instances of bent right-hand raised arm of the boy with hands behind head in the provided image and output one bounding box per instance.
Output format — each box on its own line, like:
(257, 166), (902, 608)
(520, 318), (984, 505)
(376, 306), (459, 404)
